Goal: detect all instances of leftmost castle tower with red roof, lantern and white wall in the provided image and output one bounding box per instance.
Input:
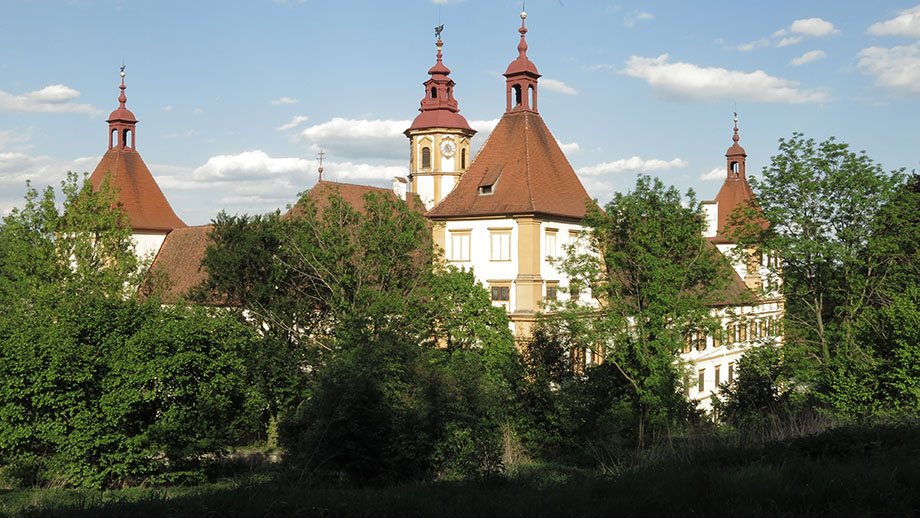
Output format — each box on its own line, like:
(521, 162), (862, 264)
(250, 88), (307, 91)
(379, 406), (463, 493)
(90, 68), (186, 257)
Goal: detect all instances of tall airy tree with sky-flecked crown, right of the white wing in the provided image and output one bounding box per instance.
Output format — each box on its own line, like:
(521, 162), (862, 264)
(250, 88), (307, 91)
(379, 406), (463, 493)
(734, 133), (901, 363)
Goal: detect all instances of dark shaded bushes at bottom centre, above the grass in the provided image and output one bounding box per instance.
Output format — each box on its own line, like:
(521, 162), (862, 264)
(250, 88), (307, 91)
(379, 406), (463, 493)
(281, 335), (507, 485)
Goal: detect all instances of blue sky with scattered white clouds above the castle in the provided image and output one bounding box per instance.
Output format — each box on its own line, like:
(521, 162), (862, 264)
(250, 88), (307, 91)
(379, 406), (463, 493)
(0, 0), (920, 225)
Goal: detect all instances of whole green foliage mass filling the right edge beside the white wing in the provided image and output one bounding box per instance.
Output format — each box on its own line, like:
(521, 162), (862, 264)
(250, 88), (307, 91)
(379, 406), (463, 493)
(729, 133), (920, 426)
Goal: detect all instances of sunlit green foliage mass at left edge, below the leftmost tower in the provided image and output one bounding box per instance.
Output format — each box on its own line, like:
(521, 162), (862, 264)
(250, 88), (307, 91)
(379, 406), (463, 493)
(0, 175), (254, 487)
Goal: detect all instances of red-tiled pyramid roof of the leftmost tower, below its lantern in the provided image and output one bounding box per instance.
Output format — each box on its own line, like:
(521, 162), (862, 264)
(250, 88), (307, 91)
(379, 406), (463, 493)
(90, 148), (186, 231)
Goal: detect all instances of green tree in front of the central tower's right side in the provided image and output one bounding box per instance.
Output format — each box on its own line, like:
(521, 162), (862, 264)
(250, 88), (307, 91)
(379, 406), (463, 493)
(558, 176), (731, 446)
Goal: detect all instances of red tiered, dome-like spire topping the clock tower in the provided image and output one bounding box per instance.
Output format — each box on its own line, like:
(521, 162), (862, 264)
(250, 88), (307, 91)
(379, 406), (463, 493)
(406, 25), (473, 136)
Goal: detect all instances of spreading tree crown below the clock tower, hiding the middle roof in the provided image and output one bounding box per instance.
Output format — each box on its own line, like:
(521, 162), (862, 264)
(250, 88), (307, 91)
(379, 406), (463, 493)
(195, 192), (446, 419)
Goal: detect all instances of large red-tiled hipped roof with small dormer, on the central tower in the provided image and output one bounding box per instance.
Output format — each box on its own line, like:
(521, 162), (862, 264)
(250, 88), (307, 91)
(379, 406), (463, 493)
(426, 111), (591, 219)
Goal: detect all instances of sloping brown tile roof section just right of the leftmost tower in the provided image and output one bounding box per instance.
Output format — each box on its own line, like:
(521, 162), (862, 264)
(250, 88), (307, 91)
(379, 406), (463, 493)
(146, 225), (214, 303)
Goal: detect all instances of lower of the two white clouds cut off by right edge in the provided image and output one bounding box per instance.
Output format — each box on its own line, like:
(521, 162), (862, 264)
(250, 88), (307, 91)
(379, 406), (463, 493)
(856, 42), (920, 95)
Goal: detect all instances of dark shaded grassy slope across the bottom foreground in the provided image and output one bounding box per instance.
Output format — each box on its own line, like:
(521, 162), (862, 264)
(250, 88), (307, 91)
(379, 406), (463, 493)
(0, 425), (920, 518)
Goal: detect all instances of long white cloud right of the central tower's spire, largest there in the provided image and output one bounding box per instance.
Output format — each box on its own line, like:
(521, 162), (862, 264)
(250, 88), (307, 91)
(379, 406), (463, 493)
(623, 54), (828, 104)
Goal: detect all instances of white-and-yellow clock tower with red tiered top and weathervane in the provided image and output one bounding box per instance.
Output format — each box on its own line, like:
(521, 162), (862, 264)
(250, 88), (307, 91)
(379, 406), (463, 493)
(405, 26), (476, 209)
